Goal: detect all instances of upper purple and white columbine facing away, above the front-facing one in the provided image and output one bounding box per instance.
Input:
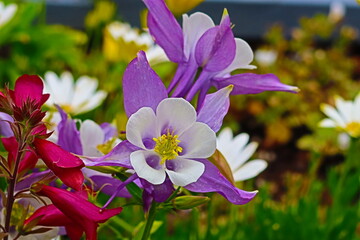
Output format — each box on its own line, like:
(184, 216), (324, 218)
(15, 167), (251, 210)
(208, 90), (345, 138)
(143, 0), (298, 107)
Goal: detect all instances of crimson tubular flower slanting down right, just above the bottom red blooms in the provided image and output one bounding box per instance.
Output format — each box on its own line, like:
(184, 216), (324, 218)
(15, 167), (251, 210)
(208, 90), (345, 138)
(33, 138), (85, 190)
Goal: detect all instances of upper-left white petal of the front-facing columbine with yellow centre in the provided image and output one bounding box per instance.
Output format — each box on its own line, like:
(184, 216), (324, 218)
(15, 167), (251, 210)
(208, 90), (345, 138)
(126, 107), (160, 149)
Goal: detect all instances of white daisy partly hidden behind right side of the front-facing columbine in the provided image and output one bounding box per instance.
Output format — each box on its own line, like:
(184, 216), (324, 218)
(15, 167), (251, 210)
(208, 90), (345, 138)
(216, 128), (267, 182)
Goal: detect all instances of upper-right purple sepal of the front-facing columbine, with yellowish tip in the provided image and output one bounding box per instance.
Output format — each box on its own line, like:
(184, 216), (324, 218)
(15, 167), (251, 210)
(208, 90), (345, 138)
(197, 87), (232, 132)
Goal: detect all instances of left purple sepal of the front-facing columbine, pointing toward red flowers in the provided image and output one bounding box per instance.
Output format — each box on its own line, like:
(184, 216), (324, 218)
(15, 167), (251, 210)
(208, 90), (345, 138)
(84, 140), (140, 168)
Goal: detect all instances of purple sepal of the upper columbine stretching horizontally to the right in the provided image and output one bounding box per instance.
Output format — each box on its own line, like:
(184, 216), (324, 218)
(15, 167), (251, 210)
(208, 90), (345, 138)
(213, 73), (299, 95)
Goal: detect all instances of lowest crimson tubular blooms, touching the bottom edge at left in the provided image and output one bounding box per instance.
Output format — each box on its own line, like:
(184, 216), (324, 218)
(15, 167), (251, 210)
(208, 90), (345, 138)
(25, 185), (122, 240)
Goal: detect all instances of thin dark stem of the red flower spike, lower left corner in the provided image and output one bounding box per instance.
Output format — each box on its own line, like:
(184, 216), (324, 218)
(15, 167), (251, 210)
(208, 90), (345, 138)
(4, 141), (26, 240)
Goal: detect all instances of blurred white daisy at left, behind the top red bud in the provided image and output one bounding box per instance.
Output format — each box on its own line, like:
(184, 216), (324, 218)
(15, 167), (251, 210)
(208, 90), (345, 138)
(44, 72), (107, 115)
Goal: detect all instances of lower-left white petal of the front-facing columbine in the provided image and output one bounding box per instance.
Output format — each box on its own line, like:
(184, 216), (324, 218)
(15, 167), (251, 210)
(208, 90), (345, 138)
(130, 150), (166, 185)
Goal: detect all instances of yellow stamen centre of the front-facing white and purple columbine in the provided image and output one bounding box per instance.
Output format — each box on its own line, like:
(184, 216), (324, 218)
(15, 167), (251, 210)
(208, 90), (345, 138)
(153, 131), (182, 164)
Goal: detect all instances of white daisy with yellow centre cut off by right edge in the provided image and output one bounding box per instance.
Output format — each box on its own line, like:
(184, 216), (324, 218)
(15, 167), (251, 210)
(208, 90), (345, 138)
(319, 93), (360, 138)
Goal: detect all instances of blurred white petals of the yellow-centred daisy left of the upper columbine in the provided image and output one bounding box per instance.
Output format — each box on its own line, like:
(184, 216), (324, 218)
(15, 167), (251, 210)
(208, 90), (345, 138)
(107, 21), (168, 65)
